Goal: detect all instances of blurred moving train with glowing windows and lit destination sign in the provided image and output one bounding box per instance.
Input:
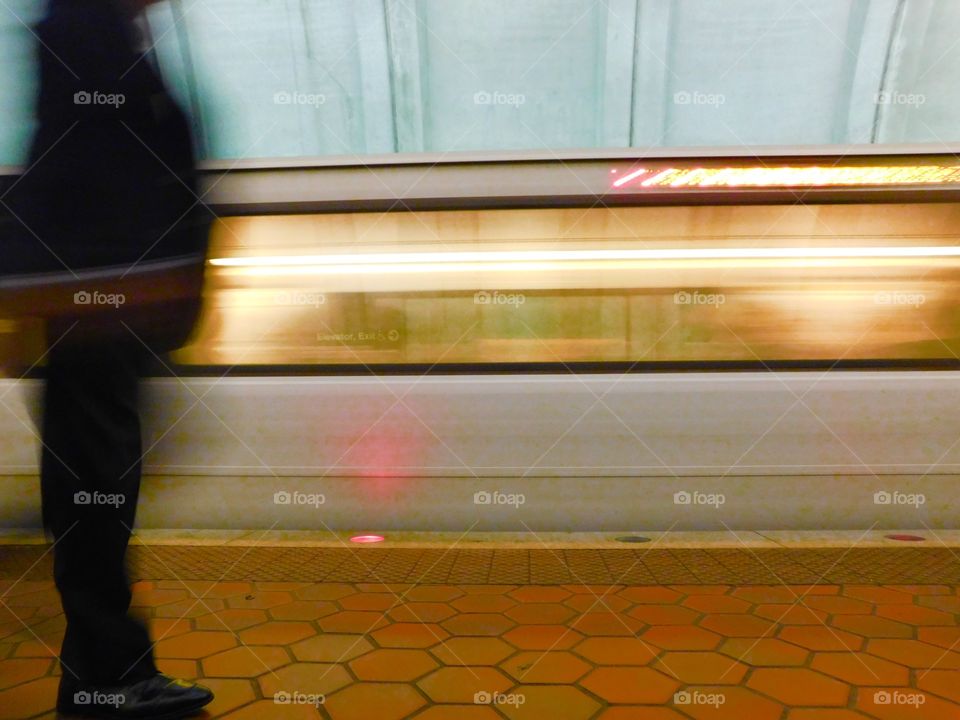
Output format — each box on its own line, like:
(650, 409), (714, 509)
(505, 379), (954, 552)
(0, 146), (960, 531)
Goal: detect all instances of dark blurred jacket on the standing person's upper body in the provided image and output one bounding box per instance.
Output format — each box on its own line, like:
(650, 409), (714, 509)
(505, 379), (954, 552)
(0, 0), (211, 274)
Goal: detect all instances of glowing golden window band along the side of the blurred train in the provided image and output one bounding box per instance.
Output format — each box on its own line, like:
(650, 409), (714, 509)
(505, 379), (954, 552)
(175, 204), (960, 366)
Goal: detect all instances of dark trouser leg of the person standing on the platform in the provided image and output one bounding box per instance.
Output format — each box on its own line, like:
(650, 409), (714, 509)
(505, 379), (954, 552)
(41, 340), (156, 686)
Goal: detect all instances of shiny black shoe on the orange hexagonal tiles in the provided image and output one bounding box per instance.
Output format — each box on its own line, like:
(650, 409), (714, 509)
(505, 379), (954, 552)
(57, 673), (213, 720)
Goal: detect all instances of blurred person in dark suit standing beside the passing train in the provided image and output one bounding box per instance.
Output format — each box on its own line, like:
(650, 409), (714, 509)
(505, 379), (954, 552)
(0, 0), (213, 719)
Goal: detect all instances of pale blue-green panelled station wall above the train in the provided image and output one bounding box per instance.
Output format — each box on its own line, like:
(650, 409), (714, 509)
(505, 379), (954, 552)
(0, 0), (960, 164)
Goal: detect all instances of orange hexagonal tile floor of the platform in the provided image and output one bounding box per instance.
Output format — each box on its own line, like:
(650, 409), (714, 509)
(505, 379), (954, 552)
(0, 579), (960, 720)
